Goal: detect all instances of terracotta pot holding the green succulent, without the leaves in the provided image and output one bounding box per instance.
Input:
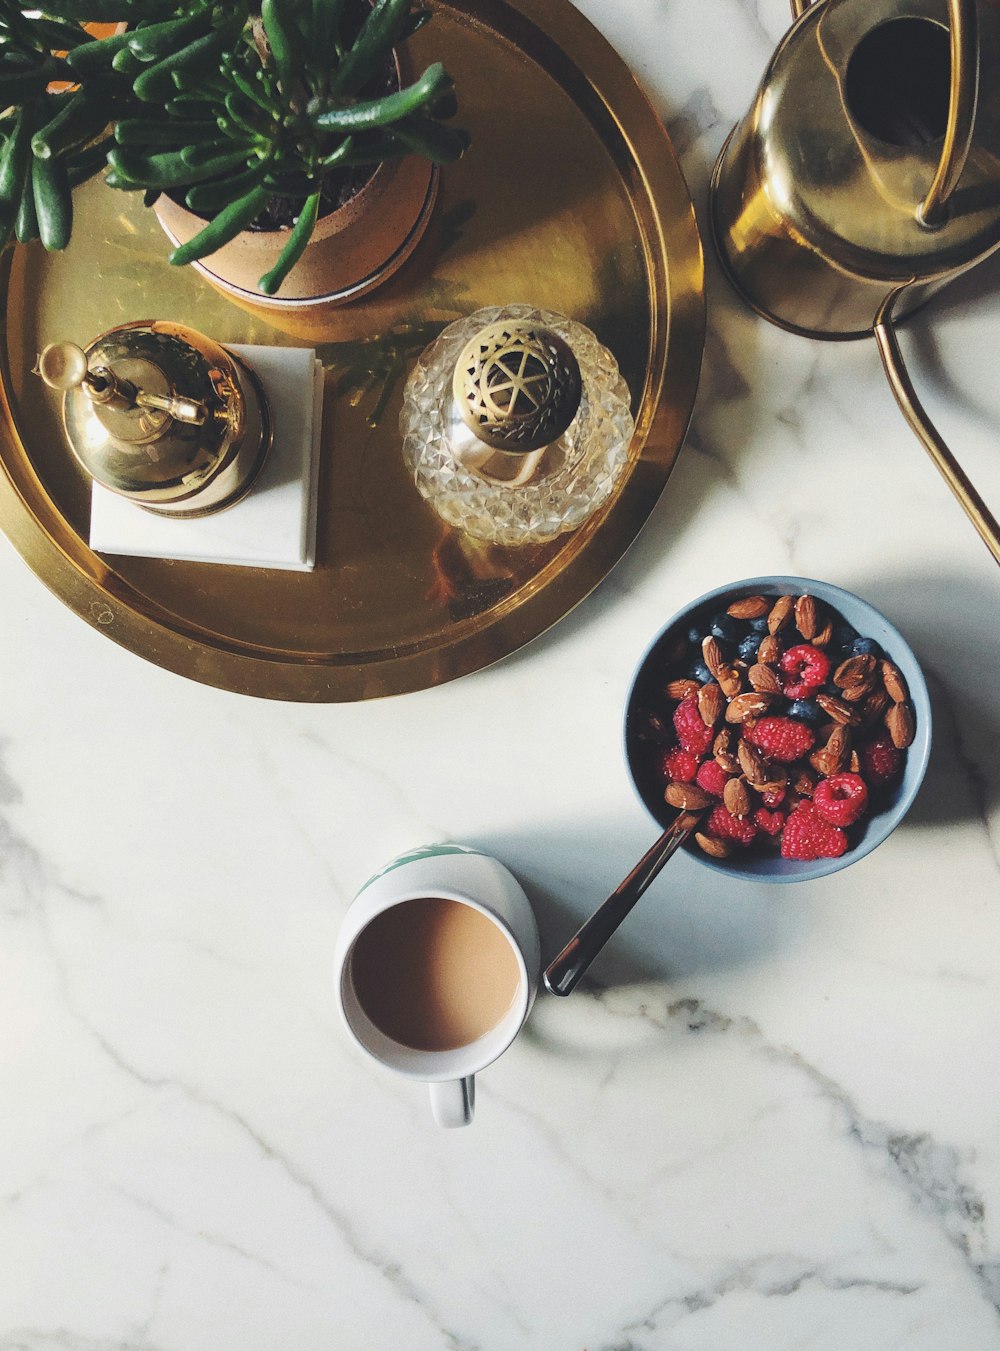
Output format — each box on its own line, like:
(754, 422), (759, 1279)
(153, 155), (441, 317)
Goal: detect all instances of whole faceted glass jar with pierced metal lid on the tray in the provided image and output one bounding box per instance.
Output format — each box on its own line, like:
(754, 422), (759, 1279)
(400, 305), (635, 546)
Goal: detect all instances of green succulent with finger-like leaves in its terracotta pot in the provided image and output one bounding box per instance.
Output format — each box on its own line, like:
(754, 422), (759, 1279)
(0, 0), (468, 304)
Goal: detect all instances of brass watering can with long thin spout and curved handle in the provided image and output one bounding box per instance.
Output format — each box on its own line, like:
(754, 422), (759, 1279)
(711, 0), (1000, 563)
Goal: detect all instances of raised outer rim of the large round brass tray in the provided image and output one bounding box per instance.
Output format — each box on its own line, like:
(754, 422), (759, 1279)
(0, 0), (705, 703)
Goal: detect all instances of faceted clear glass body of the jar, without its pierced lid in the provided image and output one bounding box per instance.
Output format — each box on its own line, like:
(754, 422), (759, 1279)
(400, 305), (635, 546)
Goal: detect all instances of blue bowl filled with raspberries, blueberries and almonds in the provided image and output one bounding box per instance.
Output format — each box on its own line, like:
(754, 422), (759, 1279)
(624, 577), (931, 882)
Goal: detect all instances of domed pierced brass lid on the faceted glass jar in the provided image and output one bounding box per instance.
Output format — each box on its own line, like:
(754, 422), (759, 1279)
(453, 322), (582, 454)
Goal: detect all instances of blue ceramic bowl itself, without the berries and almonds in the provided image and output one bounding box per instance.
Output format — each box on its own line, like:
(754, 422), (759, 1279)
(624, 577), (931, 882)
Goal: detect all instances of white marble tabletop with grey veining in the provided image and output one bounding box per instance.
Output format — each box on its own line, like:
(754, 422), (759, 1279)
(0, 0), (1000, 1351)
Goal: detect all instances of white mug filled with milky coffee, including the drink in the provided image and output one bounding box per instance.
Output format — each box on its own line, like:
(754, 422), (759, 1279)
(335, 844), (539, 1125)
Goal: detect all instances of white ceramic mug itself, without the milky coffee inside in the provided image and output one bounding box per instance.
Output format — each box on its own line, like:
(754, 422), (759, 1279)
(334, 844), (541, 1127)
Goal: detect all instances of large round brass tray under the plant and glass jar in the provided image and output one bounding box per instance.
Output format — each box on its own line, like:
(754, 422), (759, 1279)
(0, 0), (704, 701)
